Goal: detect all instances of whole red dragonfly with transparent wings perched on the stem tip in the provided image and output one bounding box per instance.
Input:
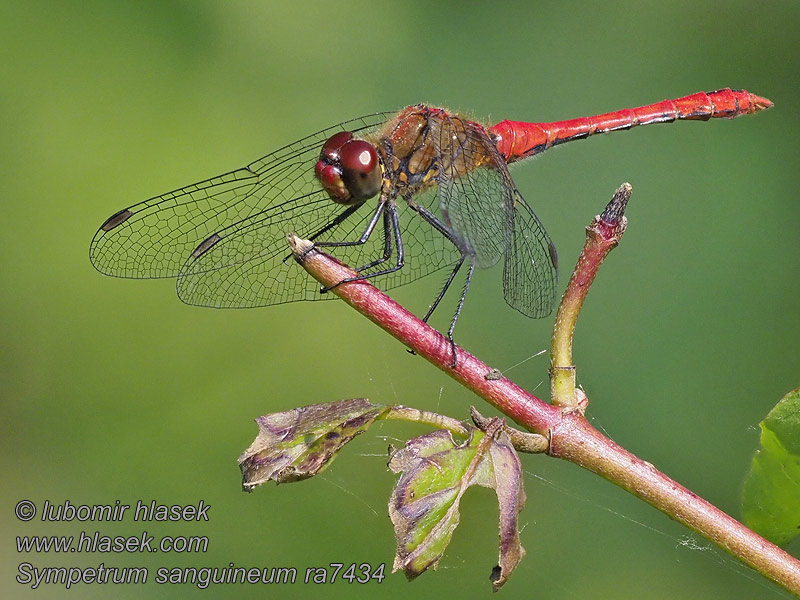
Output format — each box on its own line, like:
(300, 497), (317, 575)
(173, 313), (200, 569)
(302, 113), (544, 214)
(90, 89), (772, 350)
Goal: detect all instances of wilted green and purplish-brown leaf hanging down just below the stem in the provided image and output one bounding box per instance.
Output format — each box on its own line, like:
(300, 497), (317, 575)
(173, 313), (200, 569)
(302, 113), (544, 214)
(389, 419), (525, 591)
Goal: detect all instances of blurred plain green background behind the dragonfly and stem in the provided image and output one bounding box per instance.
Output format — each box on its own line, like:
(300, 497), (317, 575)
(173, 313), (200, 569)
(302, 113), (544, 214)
(0, 0), (800, 599)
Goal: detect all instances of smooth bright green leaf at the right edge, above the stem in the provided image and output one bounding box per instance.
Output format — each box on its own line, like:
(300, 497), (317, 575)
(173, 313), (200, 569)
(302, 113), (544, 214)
(742, 388), (800, 545)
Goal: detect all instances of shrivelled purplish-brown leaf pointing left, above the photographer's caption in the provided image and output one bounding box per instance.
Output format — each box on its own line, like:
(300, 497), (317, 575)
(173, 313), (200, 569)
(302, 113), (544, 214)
(239, 398), (389, 492)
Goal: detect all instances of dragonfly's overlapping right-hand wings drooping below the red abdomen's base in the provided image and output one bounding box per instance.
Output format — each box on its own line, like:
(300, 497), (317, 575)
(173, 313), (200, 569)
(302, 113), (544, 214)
(434, 117), (558, 318)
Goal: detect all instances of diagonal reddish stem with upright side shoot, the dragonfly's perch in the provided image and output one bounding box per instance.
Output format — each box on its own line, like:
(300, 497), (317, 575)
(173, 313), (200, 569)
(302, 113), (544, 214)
(289, 180), (800, 595)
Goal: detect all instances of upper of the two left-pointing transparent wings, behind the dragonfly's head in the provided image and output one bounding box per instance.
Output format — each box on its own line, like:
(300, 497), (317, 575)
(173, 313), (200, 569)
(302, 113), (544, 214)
(89, 113), (391, 279)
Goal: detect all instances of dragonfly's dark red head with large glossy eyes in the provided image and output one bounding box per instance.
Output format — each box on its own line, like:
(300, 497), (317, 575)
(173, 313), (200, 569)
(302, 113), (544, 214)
(314, 131), (383, 205)
